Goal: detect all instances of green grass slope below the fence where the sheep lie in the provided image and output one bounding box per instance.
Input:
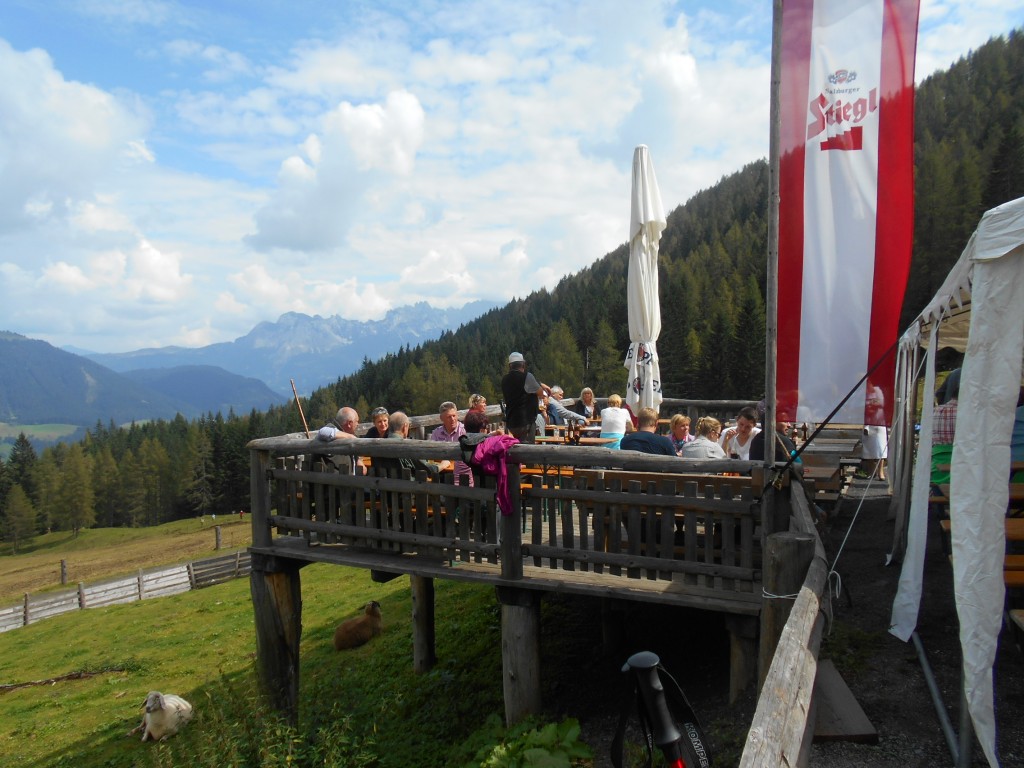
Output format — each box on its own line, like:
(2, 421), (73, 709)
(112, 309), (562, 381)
(0, 564), (502, 768)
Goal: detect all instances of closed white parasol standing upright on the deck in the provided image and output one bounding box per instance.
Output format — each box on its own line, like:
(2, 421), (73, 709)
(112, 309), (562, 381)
(623, 144), (666, 413)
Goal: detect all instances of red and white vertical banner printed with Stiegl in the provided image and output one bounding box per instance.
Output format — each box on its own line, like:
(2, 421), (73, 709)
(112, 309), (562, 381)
(776, 0), (919, 425)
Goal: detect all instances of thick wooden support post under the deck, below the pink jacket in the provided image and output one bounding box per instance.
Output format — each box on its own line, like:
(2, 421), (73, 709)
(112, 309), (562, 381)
(497, 587), (541, 725)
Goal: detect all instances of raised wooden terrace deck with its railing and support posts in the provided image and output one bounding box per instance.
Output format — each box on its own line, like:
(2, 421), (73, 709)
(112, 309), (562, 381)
(249, 436), (802, 722)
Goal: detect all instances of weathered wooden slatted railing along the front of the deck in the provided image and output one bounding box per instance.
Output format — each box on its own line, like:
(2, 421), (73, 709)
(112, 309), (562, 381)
(250, 437), (761, 615)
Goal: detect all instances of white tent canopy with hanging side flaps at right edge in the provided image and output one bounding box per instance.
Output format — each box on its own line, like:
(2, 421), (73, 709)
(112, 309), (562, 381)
(889, 198), (1024, 766)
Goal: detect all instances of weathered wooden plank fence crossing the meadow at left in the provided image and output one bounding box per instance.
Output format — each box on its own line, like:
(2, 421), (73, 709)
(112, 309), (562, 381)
(0, 551), (250, 632)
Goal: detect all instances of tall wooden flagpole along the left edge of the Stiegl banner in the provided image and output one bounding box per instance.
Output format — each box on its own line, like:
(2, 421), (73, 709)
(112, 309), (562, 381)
(764, 0), (782, 456)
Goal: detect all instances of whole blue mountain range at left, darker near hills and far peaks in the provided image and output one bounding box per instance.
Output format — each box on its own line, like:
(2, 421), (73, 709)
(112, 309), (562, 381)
(0, 301), (496, 434)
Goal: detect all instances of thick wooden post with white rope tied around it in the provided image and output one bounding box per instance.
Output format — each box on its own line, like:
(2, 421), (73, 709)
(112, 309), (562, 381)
(758, 531), (814, 690)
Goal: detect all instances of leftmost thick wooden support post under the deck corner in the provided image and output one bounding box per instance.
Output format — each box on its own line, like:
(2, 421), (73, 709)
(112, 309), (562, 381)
(249, 556), (302, 725)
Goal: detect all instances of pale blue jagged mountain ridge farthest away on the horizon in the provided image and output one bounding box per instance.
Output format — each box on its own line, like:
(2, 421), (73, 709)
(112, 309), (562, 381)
(87, 301), (499, 396)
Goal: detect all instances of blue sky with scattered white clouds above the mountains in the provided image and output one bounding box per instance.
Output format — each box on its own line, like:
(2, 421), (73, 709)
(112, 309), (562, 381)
(0, 0), (1024, 351)
